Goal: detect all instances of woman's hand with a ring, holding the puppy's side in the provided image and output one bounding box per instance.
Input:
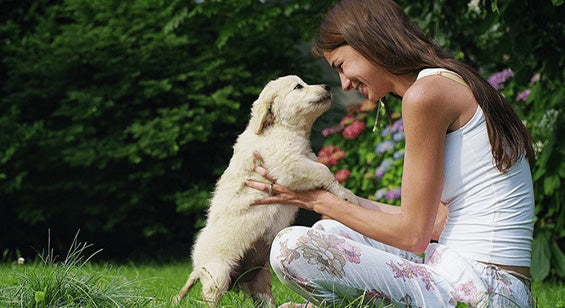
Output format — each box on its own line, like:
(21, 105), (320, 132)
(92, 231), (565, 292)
(245, 151), (343, 214)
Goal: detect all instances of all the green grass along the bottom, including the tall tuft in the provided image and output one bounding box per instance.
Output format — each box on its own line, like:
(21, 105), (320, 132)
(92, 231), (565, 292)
(0, 238), (565, 308)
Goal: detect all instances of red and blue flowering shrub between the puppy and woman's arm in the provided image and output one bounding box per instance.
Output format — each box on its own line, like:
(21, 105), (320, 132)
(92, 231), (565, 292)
(318, 99), (404, 205)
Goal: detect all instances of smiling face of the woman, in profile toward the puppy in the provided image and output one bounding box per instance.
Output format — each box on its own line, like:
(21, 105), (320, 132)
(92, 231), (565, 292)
(324, 45), (399, 102)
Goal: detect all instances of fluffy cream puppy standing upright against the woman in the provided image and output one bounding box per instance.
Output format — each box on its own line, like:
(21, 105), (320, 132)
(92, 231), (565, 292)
(177, 76), (358, 306)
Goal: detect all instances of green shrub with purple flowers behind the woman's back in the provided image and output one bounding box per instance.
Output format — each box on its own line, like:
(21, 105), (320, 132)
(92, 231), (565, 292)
(489, 69), (565, 280)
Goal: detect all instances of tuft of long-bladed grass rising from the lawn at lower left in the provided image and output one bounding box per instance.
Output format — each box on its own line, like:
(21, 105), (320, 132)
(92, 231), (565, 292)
(0, 233), (156, 307)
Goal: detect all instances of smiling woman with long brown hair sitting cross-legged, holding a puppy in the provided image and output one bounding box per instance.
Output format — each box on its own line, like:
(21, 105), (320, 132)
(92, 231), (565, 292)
(246, 0), (534, 307)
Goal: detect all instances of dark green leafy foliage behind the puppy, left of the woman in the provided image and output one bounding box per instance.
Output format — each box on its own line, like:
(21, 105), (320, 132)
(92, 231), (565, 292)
(0, 0), (332, 255)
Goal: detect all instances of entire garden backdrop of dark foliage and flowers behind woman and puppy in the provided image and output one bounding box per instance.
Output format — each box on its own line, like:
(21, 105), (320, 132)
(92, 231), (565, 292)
(0, 0), (565, 294)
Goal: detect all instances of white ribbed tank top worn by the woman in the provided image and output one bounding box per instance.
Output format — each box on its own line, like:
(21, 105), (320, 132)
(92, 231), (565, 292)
(418, 69), (534, 267)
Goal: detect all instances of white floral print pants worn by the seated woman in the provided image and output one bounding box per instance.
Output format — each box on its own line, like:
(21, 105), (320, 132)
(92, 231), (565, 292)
(271, 220), (533, 307)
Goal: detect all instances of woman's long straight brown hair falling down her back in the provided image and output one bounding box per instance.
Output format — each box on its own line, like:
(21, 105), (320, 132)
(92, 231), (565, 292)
(312, 0), (534, 172)
